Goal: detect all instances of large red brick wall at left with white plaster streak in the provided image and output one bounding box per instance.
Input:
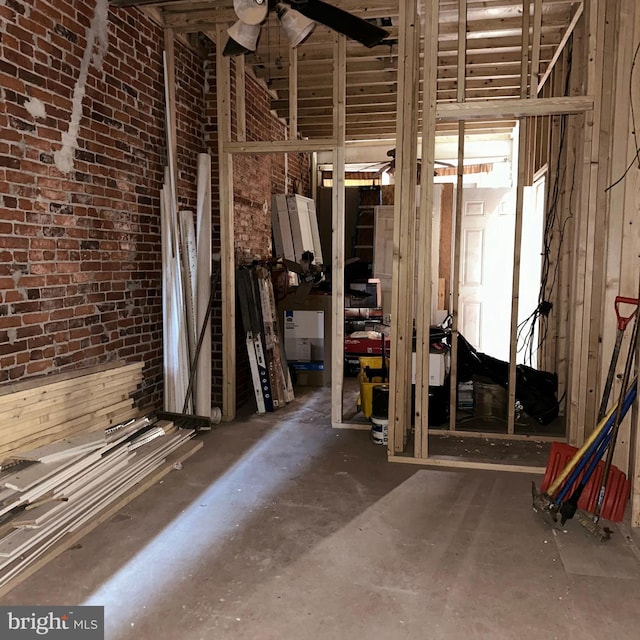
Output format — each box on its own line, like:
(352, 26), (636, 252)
(0, 0), (203, 405)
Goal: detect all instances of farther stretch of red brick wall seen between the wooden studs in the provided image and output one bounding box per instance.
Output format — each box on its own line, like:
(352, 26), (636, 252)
(206, 50), (311, 405)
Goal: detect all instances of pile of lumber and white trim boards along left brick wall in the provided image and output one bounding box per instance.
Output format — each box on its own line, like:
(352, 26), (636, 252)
(0, 362), (202, 593)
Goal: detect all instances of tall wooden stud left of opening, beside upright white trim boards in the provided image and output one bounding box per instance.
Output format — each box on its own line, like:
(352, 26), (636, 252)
(215, 25), (236, 420)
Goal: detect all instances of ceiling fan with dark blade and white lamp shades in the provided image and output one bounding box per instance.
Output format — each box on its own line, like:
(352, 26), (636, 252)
(223, 0), (389, 56)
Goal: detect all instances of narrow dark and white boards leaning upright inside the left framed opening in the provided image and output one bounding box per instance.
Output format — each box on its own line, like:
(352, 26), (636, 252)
(236, 266), (294, 413)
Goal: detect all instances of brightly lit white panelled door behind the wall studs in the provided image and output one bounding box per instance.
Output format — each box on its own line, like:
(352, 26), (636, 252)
(458, 188), (515, 361)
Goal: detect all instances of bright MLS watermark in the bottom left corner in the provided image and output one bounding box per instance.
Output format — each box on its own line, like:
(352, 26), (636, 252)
(0, 606), (104, 640)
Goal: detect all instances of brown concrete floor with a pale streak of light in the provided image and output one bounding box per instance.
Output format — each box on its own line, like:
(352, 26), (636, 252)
(1, 390), (640, 640)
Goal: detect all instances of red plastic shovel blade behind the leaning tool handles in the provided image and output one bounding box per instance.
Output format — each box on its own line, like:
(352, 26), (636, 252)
(540, 442), (631, 522)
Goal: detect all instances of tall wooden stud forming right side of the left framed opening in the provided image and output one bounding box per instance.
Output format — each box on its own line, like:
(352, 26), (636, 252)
(331, 33), (347, 425)
